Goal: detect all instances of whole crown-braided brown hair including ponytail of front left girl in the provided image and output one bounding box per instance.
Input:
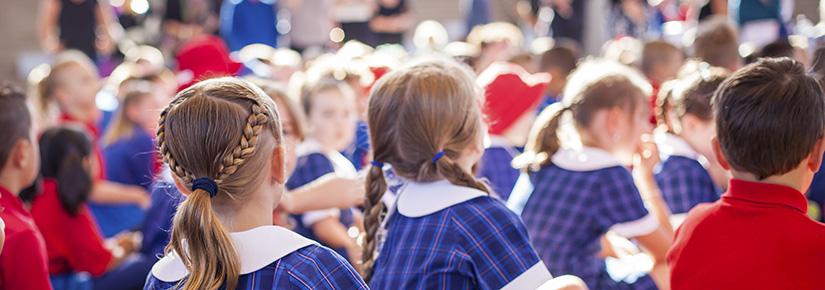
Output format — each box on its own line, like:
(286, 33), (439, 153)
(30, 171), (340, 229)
(157, 77), (282, 290)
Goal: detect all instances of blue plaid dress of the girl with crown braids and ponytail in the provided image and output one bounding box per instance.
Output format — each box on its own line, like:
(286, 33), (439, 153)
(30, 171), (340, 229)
(143, 245), (369, 290)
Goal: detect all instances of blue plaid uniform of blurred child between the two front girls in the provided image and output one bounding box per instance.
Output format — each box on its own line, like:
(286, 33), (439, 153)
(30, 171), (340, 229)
(286, 153), (354, 257)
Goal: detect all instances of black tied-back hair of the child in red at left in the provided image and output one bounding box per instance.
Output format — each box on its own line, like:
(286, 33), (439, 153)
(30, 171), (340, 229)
(40, 127), (92, 215)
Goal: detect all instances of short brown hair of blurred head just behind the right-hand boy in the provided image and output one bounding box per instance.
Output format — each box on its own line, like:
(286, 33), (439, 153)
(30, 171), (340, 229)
(693, 17), (741, 69)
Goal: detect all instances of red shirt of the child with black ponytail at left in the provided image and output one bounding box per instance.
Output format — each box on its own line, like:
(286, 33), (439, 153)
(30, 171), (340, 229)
(32, 179), (112, 276)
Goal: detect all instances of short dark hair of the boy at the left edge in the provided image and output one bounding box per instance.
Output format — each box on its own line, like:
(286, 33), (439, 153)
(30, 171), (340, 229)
(0, 84), (32, 168)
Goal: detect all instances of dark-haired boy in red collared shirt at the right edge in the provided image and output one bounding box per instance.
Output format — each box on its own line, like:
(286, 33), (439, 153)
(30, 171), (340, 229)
(668, 58), (825, 289)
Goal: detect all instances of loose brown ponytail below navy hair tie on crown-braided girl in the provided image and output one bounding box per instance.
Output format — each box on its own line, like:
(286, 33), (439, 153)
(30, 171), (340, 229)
(167, 189), (241, 290)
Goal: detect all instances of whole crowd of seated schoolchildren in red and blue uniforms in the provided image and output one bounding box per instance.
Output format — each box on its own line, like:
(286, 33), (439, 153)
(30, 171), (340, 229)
(0, 8), (825, 290)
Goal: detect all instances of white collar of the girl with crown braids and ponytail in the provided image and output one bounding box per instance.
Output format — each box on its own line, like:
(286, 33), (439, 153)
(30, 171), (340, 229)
(152, 226), (317, 282)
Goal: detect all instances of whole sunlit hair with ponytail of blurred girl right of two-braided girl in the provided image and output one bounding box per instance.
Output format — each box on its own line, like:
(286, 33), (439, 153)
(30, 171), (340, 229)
(513, 60), (650, 171)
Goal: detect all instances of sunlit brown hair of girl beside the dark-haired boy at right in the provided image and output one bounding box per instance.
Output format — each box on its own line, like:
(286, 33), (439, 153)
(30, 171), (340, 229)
(656, 63), (730, 132)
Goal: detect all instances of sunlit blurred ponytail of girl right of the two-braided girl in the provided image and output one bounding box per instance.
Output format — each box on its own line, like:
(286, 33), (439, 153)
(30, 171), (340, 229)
(513, 103), (571, 172)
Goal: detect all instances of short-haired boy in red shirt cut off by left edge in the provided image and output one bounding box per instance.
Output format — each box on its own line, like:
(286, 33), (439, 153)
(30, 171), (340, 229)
(0, 85), (52, 290)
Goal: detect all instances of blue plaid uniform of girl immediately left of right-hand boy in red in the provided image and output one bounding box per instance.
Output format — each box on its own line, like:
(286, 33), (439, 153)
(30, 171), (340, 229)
(656, 156), (720, 214)
